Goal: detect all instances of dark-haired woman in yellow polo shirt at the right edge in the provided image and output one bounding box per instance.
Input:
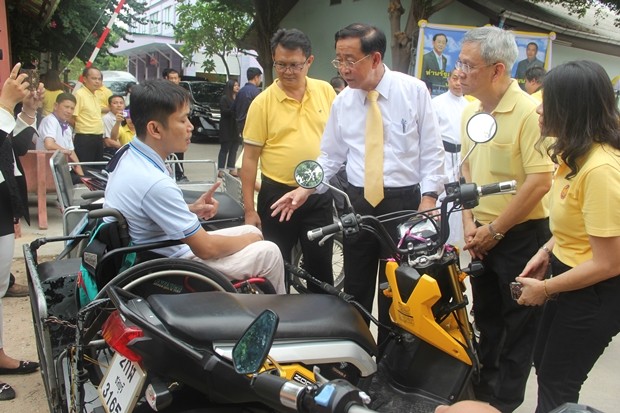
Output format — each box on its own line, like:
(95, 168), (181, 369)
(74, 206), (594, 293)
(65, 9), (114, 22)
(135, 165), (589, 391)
(517, 60), (620, 413)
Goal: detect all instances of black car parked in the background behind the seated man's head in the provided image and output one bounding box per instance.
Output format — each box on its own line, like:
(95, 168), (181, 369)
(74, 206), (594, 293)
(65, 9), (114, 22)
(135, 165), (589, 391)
(180, 80), (225, 142)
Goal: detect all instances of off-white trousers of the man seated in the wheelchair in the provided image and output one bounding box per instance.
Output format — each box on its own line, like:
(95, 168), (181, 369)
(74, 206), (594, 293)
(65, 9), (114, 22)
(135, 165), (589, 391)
(183, 225), (286, 294)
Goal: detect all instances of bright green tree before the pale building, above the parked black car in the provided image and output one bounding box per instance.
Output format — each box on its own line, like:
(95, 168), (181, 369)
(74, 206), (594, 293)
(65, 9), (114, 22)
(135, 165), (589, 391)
(174, 0), (252, 76)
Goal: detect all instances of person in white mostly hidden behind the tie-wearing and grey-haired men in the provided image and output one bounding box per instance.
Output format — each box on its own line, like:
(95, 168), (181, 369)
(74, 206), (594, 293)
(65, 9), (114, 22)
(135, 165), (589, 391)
(432, 69), (468, 245)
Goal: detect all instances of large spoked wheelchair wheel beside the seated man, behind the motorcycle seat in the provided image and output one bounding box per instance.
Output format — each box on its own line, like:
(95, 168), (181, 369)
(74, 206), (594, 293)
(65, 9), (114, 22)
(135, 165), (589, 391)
(68, 258), (237, 408)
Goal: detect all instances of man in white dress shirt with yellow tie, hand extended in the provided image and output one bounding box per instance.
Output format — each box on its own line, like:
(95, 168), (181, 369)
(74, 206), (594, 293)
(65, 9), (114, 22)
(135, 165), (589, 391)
(272, 23), (446, 343)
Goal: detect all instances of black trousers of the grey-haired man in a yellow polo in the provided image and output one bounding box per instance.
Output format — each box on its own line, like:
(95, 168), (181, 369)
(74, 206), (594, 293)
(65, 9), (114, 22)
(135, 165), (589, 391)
(471, 219), (551, 413)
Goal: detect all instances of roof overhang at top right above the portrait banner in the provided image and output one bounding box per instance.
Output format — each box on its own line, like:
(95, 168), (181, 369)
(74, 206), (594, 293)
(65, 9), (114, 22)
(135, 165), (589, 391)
(460, 0), (620, 57)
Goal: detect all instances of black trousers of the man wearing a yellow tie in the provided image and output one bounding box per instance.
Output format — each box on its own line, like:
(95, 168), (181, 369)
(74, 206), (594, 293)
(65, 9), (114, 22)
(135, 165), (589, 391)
(344, 184), (421, 344)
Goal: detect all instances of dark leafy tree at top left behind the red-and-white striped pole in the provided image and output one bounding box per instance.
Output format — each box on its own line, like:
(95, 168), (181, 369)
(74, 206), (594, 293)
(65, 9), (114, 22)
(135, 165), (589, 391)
(7, 0), (146, 69)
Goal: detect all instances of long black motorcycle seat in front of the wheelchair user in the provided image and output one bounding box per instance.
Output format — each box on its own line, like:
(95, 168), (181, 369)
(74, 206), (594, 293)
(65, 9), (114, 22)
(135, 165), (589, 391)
(147, 292), (377, 355)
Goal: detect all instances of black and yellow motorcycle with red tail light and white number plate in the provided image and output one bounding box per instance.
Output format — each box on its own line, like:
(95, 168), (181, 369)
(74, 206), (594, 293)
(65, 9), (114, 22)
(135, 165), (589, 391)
(31, 115), (514, 413)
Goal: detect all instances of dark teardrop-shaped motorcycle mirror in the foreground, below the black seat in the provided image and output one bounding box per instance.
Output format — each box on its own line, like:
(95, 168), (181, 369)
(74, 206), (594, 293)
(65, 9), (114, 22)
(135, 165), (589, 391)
(232, 310), (280, 374)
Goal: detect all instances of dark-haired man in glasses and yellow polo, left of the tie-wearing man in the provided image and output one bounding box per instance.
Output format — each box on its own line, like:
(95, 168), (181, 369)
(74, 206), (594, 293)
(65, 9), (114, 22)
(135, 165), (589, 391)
(241, 29), (336, 292)
